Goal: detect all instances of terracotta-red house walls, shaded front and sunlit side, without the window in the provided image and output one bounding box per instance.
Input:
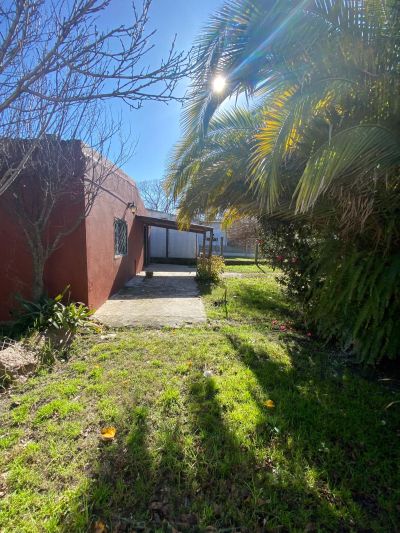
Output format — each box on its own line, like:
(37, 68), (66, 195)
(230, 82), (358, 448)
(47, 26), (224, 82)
(0, 141), (146, 321)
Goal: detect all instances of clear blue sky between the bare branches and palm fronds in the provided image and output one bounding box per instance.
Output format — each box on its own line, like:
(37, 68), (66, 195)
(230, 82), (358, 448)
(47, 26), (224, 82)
(109, 0), (221, 181)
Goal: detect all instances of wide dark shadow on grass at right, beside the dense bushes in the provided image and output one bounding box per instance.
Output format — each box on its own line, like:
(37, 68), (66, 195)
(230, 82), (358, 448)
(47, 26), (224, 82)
(227, 333), (399, 531)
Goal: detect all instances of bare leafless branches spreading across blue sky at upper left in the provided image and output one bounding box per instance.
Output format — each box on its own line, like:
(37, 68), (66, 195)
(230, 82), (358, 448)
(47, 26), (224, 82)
(0, 0), (191, 194)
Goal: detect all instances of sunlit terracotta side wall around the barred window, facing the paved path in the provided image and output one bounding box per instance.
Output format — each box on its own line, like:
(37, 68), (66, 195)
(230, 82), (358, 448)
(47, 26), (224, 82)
(85, 166), (146, 308)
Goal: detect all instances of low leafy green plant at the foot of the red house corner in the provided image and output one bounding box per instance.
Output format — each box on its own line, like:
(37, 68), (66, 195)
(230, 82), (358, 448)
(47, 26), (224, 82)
(15, 286), (93, 333)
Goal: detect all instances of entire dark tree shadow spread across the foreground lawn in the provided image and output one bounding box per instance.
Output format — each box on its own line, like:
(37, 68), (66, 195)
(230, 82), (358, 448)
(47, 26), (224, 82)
(63, 328), (396, 533)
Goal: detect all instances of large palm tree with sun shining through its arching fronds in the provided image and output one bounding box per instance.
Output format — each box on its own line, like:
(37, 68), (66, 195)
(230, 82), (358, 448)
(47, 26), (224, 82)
(168, 0), (400, 362)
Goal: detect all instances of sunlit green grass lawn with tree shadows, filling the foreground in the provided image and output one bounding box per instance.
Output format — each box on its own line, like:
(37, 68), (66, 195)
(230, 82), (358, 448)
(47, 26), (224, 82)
(0, 276), (400, 533)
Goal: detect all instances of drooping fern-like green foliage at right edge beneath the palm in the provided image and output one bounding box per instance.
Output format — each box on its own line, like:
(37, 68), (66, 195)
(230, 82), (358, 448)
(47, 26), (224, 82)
(309, 242), (400, 363)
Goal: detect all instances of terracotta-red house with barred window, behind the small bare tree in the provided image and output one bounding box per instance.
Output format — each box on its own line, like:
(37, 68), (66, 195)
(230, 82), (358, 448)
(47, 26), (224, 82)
(0, 137), (147, 321)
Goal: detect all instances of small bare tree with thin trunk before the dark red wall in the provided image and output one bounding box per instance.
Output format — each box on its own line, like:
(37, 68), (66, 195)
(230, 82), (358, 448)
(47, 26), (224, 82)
(0, 104), (130, 300)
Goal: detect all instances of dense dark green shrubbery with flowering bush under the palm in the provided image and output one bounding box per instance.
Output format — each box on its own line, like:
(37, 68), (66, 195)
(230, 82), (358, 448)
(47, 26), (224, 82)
(259, 218), (400, 364)
